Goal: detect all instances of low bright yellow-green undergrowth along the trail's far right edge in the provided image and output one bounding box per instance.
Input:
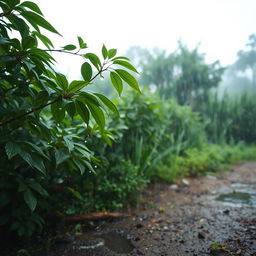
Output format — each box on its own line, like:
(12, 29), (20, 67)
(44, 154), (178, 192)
(150, 143), (256, 182)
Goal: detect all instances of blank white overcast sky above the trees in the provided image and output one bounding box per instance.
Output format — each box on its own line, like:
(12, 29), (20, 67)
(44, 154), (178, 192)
(36, 0), (256, 78)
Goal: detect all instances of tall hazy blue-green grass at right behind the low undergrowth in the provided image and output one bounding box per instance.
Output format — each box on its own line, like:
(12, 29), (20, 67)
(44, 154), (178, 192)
(196, 93), (256, 144)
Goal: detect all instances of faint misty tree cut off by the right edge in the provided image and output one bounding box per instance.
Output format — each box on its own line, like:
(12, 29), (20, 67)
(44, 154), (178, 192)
(235, 34), (256, 89)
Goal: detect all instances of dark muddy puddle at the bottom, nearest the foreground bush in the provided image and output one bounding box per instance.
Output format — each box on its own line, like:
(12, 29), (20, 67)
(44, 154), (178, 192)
(79, 232), (134, 253)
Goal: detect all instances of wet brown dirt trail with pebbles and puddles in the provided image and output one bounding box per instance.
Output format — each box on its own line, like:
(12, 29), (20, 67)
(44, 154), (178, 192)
(44, 162), (256, 256)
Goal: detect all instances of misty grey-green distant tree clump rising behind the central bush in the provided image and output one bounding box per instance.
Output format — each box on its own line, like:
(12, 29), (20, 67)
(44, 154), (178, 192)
(130, 41), (224, 105)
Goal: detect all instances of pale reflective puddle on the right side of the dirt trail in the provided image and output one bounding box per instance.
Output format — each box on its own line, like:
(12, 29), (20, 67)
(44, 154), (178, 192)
(215, 183), (256, 206)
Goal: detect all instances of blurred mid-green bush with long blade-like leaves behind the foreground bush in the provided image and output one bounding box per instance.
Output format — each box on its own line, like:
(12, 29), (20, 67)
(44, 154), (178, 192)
(88, 91), (206, 184)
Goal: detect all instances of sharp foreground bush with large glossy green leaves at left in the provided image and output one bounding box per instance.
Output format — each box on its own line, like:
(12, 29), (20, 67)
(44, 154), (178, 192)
(0, 0), (139, 236)
